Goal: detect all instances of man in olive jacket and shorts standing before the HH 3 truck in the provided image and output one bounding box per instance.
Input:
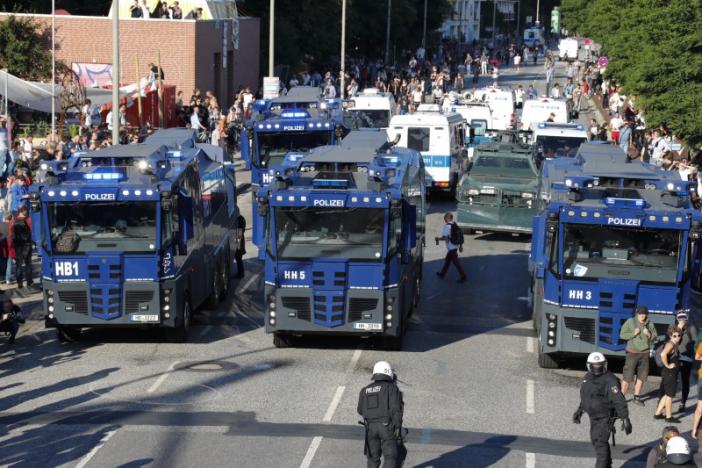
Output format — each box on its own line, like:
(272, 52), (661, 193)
(619, 306), (658, 406)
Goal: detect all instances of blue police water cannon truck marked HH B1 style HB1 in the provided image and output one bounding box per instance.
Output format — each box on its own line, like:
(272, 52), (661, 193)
(29, 129), (239, 341)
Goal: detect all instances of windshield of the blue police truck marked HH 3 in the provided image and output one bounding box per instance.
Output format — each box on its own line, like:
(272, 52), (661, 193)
(563, 224), (681, 283)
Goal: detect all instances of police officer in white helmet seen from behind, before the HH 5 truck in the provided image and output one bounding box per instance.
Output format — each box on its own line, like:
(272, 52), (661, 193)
(358, 361), (404, 468)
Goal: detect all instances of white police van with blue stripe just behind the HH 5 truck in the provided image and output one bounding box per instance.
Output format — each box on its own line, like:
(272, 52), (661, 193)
(388, 104), (467, 192)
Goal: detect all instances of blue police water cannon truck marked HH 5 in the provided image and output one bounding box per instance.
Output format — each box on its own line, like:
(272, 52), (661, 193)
(256, 131), (426, 349)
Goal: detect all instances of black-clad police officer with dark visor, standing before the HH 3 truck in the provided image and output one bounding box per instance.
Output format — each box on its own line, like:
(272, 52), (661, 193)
(573, 352), (631, 468)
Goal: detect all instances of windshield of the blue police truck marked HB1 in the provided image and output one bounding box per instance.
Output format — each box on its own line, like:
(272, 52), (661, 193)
(47, 202), (157, 253)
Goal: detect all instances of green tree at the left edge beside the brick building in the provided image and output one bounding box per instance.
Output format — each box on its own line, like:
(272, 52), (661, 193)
(0, 16), (51, 81)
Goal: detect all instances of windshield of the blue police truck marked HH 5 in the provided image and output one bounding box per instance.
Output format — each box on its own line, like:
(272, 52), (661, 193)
(275, 207), (385, 262)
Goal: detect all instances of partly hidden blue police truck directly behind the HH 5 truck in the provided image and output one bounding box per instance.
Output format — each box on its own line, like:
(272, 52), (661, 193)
(241, 86), (345, 259)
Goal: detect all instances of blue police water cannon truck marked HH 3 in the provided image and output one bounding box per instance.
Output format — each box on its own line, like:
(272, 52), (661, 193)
(529, 143), (702, 368)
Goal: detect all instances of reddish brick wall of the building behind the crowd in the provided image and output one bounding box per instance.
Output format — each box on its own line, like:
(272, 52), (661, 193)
(0, 13), (260, 108)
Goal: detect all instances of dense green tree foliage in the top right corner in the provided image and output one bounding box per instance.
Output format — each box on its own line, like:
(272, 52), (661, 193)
(562, 0), (702, 145)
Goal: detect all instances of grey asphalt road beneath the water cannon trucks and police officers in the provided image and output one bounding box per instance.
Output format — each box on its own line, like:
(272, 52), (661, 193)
(0, 60), (696, 468)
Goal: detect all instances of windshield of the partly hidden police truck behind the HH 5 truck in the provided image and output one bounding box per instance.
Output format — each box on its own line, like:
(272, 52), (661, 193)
(257, 129), (331, 167)
